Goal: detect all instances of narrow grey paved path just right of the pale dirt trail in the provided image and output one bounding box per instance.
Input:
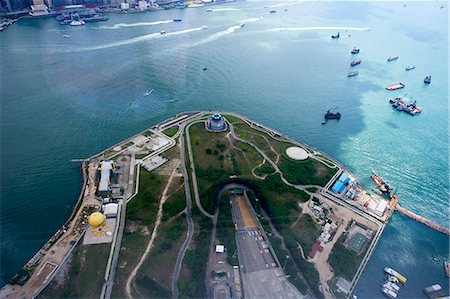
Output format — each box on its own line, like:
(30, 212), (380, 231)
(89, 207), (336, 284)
(172, 127), (194, 299)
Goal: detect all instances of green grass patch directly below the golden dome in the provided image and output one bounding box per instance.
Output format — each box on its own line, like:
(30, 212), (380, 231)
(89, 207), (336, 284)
(39, 242), (111, 298)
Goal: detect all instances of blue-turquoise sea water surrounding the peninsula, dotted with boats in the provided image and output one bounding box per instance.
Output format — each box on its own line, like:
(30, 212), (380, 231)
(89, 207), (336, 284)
(0, 1), (449, 298)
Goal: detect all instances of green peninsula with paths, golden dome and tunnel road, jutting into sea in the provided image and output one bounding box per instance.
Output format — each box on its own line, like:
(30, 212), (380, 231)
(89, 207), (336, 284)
(1, 112), (442, 298)
